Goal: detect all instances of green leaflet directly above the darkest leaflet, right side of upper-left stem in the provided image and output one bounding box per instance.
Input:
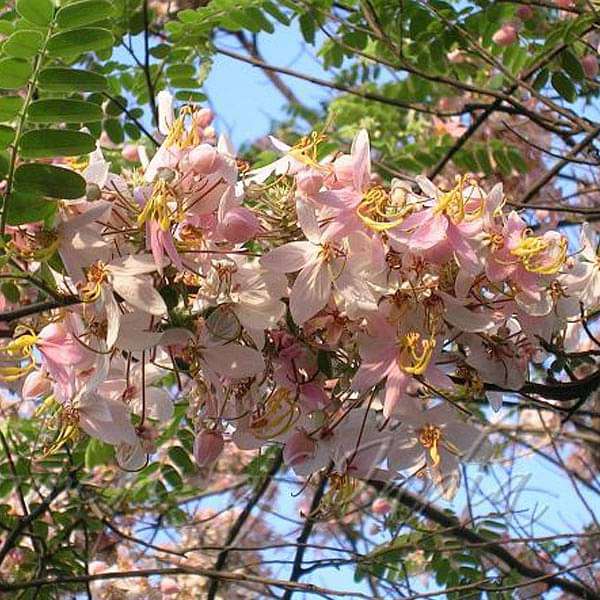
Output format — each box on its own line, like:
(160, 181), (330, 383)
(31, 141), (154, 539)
(21, 129), (96, 158)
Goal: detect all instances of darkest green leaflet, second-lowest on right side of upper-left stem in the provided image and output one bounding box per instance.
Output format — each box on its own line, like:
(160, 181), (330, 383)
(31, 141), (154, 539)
(15, 163), (85, 200)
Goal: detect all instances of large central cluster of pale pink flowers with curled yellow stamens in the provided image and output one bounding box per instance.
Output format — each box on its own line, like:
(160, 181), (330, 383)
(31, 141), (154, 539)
(0, 92), (600, 506)
